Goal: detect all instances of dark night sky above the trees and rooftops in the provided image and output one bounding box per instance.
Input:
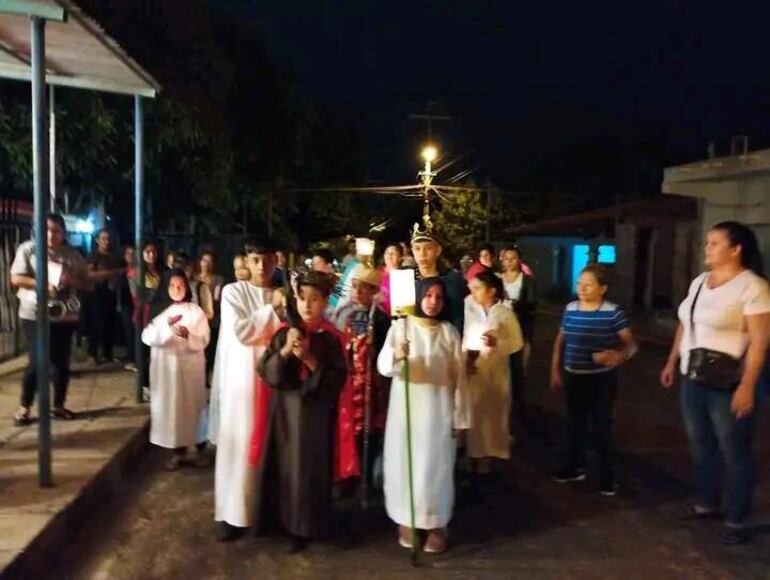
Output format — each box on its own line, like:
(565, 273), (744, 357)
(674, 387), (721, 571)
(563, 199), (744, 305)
(207, 0), (770, 193)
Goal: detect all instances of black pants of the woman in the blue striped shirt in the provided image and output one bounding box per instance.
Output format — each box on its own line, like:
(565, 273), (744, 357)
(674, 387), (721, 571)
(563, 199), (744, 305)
(564, 370), (618, 487)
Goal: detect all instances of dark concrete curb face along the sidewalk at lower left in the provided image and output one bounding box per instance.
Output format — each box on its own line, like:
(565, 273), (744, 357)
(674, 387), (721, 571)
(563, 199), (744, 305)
(0, 419), (150, 580)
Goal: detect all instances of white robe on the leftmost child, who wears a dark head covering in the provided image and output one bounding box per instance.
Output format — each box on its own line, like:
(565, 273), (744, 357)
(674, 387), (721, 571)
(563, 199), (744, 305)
(142, 302), (209, 449)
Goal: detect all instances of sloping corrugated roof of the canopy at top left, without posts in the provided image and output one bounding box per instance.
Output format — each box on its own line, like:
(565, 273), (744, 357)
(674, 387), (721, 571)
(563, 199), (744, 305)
(0, 0), (160, 98)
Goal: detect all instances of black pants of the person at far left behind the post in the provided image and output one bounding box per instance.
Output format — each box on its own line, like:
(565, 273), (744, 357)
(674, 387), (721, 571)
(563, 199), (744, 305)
(21, 320), (75, 407)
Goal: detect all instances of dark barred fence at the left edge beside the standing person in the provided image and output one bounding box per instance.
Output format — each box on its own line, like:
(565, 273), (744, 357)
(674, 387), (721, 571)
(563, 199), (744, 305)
(0, 199), (32, 362)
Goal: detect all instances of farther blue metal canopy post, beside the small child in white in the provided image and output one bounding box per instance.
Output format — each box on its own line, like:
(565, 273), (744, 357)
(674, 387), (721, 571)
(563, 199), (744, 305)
(134, 95), (145, 403)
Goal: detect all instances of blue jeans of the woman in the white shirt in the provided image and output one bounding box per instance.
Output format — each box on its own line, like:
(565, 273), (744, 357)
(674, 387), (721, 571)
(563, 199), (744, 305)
(680, 380), (757, 525)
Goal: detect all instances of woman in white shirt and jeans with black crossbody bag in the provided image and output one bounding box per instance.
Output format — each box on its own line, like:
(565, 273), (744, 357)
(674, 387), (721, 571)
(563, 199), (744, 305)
(660, 222), (770, 545)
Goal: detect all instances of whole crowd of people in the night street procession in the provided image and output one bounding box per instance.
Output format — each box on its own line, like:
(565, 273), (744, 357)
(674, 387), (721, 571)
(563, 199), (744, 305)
(11, 215), (770, 553)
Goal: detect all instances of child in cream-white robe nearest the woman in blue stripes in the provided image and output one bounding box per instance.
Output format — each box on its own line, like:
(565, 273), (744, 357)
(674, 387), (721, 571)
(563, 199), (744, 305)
(463, 270), (524, 474)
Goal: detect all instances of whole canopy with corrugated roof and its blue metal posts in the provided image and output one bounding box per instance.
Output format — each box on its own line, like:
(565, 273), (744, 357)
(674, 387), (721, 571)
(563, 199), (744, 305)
(0, 0), (160, 487)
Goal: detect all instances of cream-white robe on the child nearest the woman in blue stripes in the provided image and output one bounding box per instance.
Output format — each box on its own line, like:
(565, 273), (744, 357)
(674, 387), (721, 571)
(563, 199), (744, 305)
(463, 296), (524, 459)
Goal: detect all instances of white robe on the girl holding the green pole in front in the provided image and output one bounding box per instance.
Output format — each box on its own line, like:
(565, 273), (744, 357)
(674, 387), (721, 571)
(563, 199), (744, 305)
(377, 317), (470, 529)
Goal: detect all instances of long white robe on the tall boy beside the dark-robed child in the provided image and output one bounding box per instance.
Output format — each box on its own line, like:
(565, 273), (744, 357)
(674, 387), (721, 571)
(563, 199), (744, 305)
(209, 281), (280, 527)
